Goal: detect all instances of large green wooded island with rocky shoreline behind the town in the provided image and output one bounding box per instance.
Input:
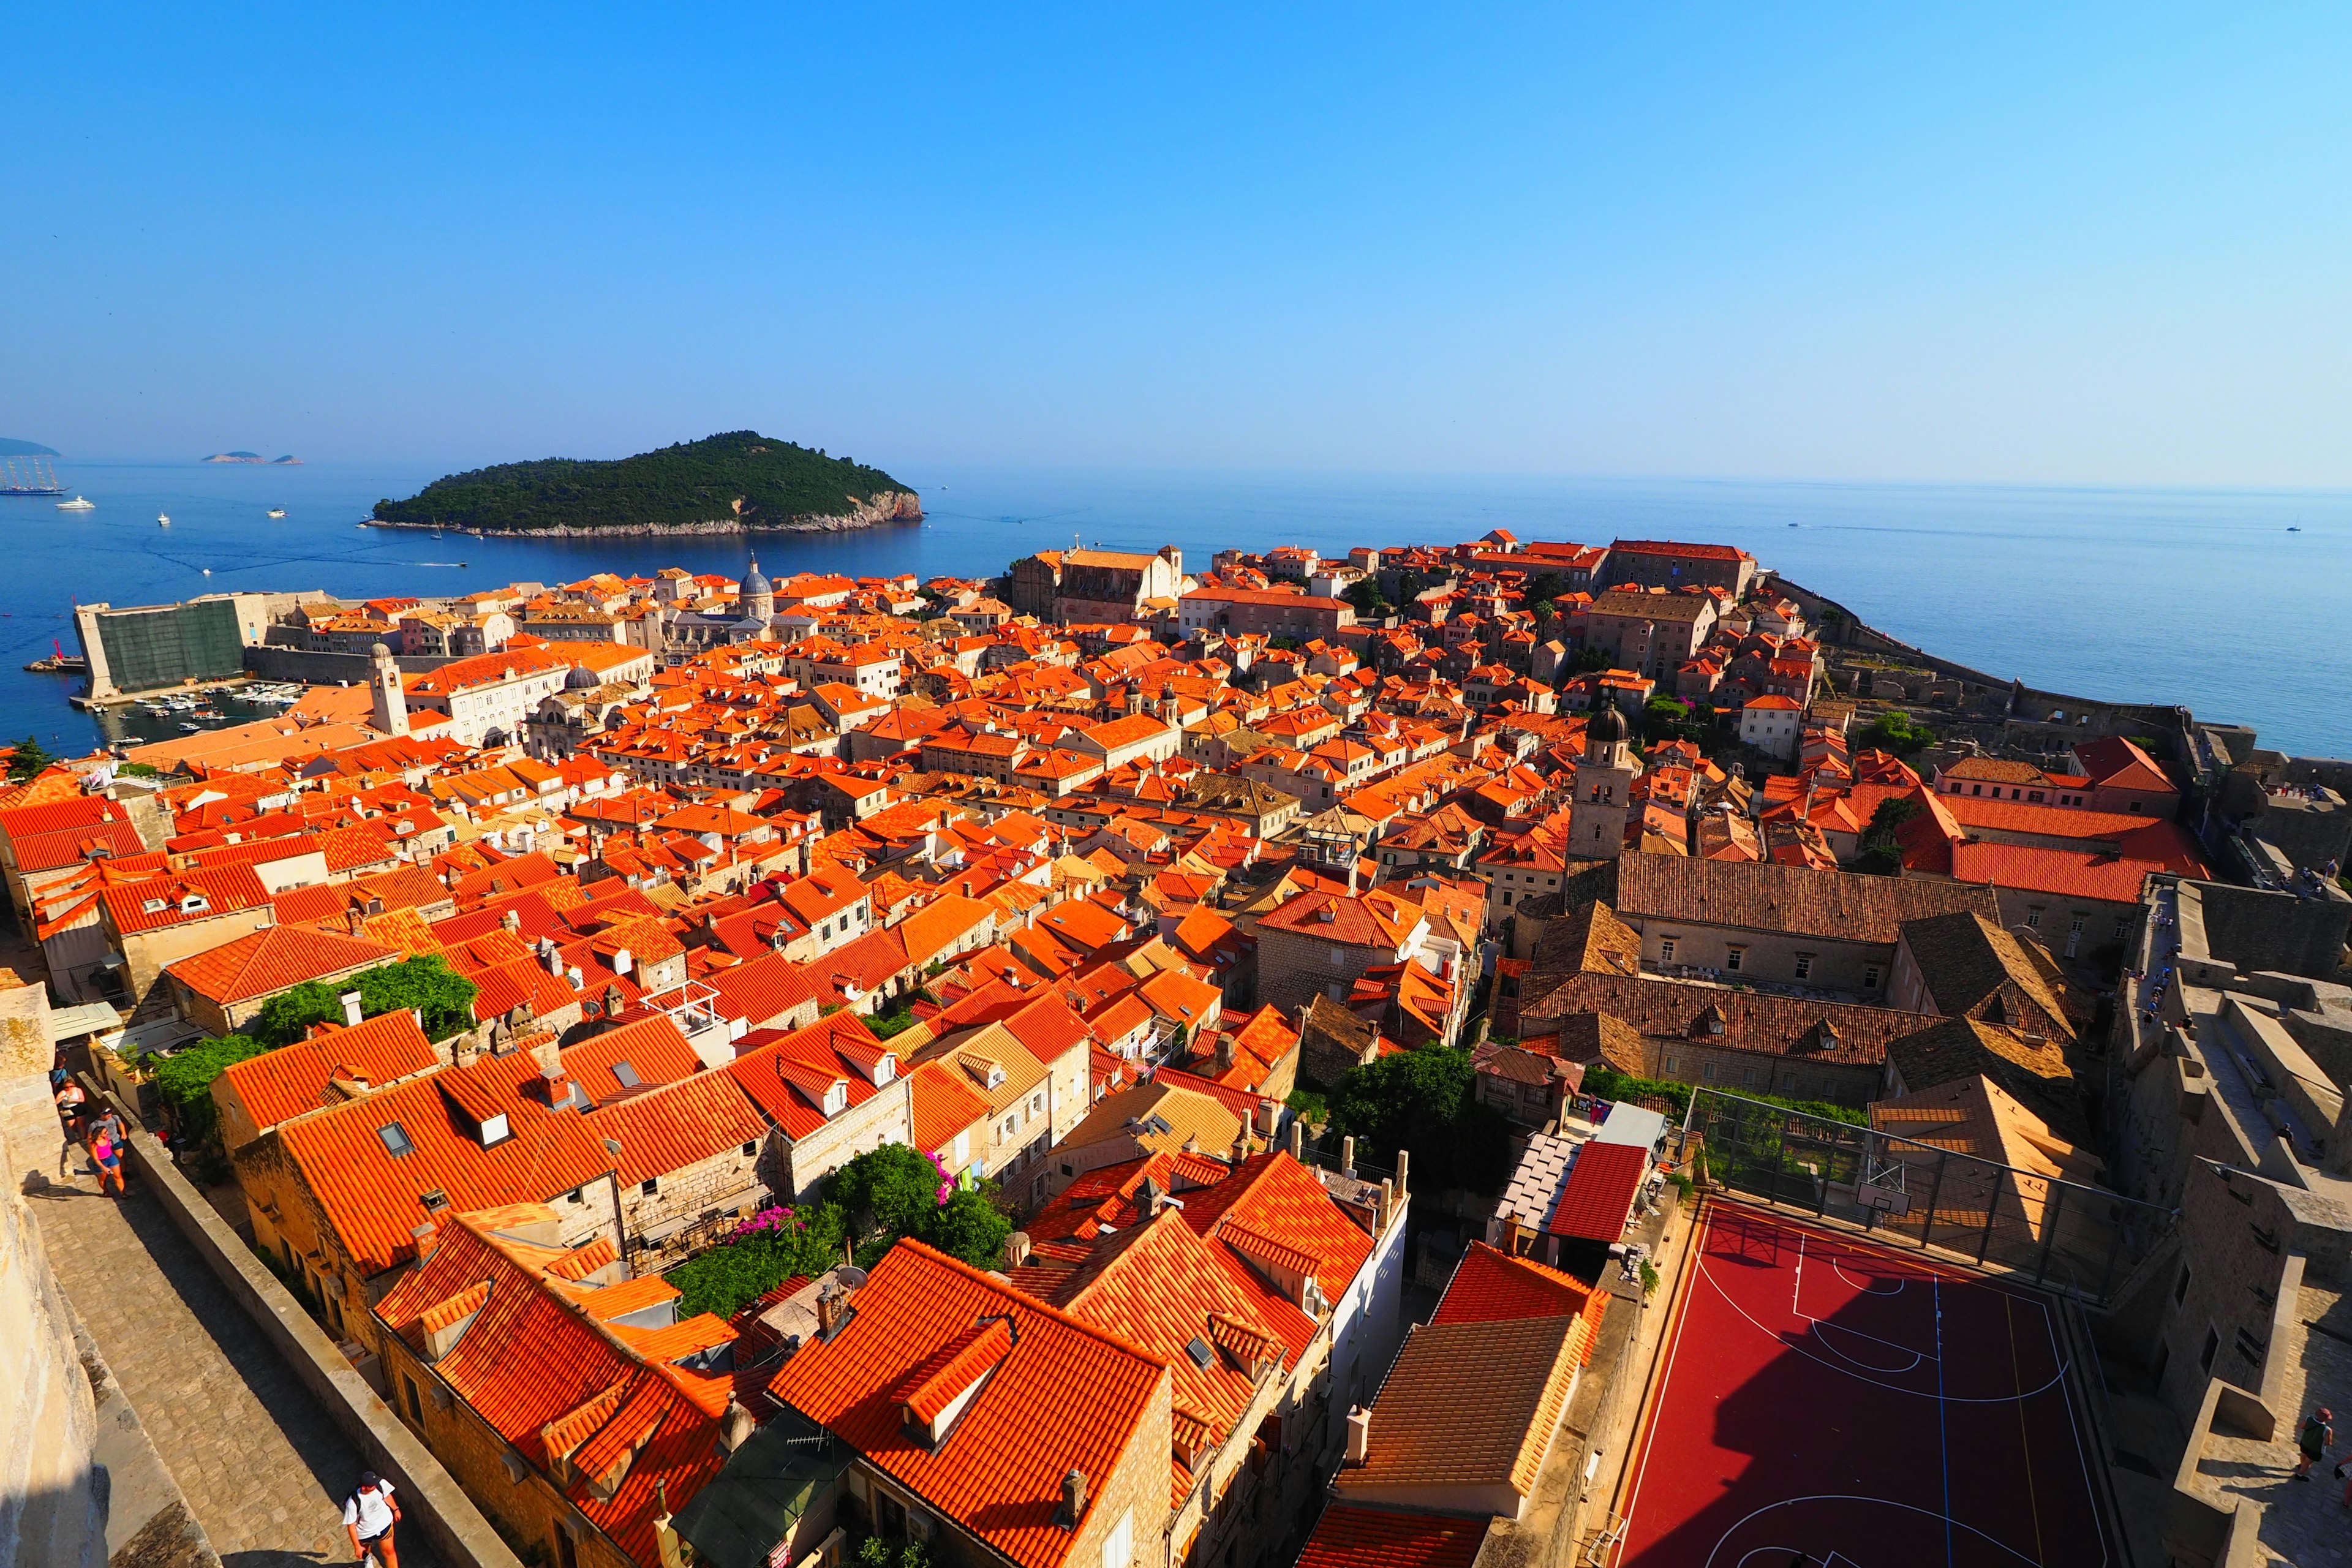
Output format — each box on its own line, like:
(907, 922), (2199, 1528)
(376, 430), (922, 533)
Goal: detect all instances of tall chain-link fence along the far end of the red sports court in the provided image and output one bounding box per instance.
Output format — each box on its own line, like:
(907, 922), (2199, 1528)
(1684, 1088), (2176, 1307)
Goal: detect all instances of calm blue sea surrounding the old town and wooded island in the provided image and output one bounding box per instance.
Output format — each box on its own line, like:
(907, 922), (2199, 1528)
(0, 461), (2352, 757)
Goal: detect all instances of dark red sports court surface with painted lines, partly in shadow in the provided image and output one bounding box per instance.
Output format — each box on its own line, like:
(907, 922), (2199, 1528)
(1613, 1204), (2117, 1568)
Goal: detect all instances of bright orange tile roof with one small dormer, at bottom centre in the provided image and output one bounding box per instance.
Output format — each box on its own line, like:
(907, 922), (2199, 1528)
(769, 1242), (1171, 1568)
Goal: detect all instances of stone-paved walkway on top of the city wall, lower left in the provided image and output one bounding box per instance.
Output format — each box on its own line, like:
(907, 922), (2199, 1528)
(26, 1152), (435, 1568)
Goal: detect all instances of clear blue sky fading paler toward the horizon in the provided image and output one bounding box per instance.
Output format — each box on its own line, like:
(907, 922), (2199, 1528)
(0, 5), (2352, 486)
